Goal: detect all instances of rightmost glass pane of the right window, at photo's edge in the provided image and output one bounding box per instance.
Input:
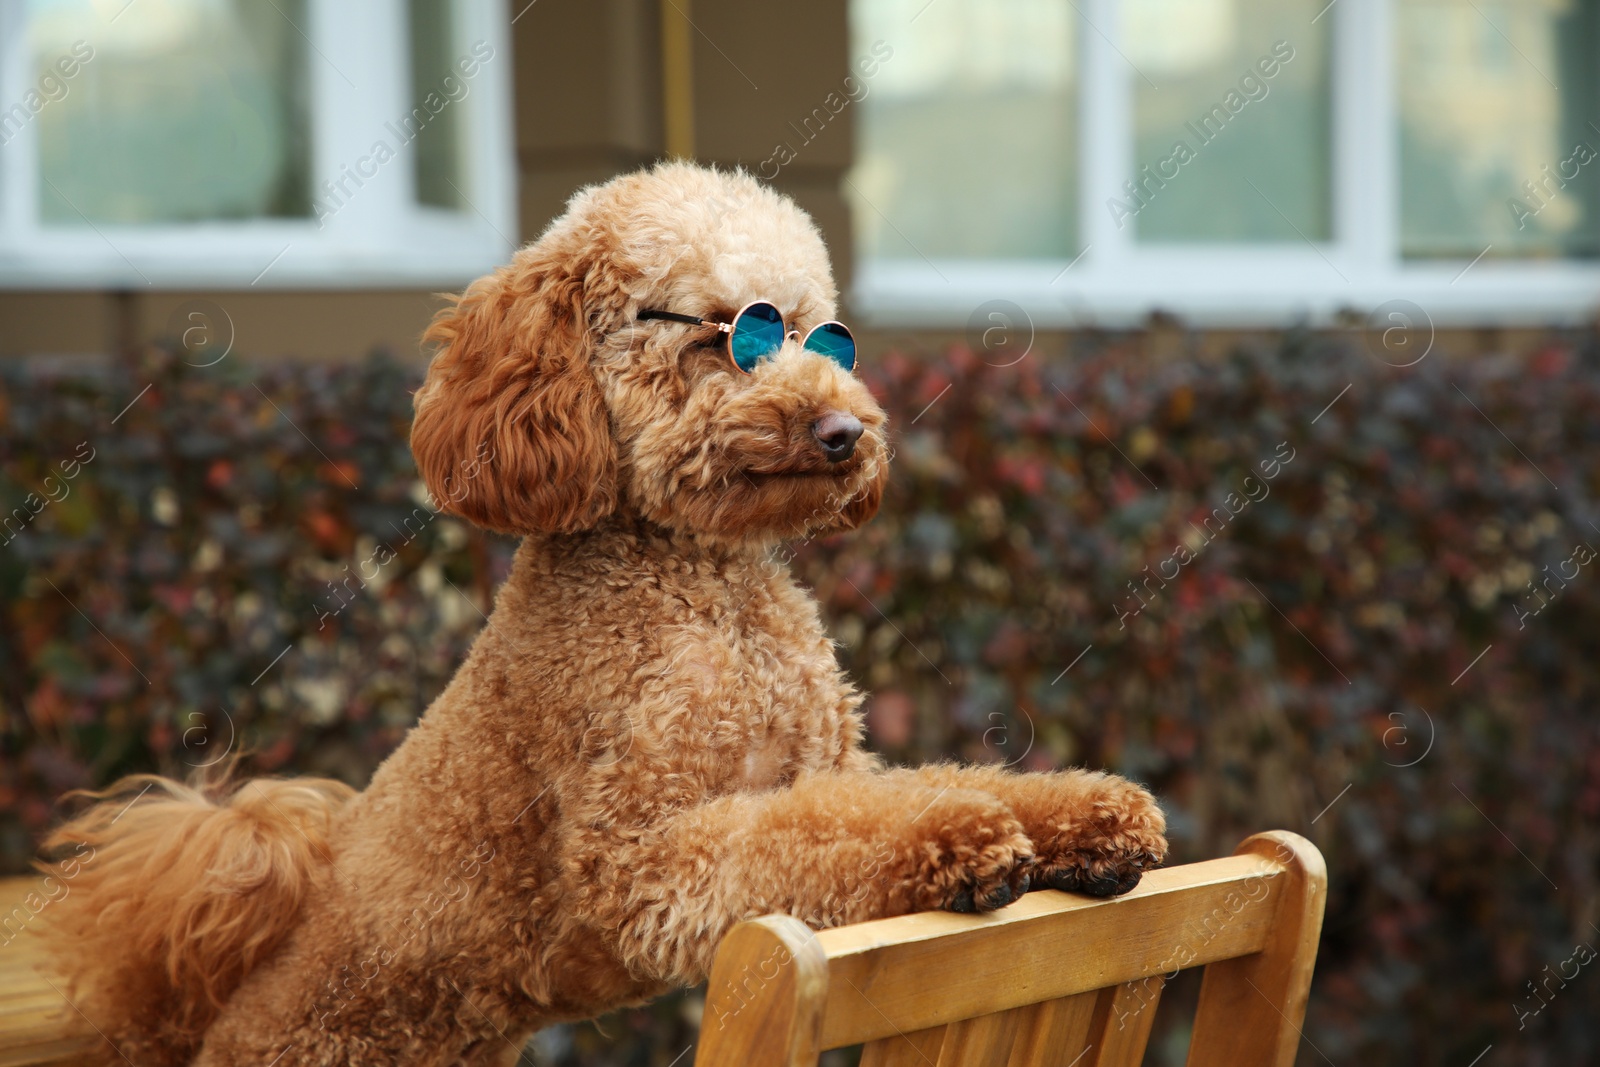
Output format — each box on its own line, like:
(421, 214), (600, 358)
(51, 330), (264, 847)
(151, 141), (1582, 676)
(1395, 0), (1600, 258)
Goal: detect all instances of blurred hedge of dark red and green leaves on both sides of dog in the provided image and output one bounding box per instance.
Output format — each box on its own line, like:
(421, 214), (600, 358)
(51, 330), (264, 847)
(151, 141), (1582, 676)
(0, 333), (1600, 1064)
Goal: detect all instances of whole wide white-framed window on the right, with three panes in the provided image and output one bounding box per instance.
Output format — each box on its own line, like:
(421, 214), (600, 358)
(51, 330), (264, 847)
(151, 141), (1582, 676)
(846, 0), (1600, 328)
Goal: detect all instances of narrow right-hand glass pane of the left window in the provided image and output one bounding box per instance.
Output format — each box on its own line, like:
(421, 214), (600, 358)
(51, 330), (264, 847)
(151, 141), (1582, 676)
(405, 0), (469, 210)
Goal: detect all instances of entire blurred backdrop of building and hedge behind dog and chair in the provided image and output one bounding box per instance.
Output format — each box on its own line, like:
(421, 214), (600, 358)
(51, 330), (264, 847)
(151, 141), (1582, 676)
(0, 0), (1600, 1067)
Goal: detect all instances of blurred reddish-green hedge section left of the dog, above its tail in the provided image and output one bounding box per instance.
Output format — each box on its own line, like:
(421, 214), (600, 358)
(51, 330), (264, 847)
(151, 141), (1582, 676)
(0, 352), (509, 844)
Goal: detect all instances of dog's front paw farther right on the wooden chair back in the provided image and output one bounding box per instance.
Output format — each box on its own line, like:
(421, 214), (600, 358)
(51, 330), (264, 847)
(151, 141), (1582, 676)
(1032, 774), (1166, 896)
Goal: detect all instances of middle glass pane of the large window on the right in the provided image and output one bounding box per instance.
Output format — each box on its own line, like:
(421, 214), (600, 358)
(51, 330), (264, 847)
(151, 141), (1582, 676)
(1126, 0), (1333, 242)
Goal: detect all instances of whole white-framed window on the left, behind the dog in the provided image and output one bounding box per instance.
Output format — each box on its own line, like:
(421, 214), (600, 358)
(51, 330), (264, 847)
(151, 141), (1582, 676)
(0, 0), (515, 288)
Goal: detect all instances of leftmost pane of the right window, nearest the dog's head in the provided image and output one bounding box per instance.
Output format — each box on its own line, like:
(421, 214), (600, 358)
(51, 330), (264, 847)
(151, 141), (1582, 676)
(851, 0), (1078, 259)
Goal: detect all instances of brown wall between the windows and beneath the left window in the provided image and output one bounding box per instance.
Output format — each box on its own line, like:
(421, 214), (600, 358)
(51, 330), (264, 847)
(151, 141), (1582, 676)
(0, 0), (853, 360)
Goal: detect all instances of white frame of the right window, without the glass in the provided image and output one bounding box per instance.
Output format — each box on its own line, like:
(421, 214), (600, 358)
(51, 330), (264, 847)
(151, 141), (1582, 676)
(851, 0), (1600, 330)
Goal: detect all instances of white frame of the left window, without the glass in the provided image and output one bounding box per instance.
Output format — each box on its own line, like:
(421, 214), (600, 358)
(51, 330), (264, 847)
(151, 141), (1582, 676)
(0, 0), (517, 290)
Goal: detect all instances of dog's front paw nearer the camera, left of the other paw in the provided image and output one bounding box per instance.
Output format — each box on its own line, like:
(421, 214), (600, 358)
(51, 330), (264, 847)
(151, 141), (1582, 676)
(904, 789), (1034, 912)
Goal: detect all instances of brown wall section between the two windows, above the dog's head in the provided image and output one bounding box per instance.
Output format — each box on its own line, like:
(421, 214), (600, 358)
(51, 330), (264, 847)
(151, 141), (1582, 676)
(515, 0), (853, 288)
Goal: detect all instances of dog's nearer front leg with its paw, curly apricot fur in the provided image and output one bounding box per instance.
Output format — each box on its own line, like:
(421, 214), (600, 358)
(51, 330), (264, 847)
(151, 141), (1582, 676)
(589, 771), (1034, 984)
